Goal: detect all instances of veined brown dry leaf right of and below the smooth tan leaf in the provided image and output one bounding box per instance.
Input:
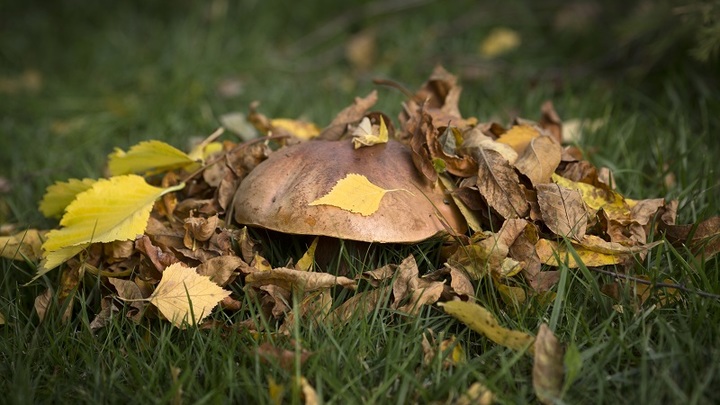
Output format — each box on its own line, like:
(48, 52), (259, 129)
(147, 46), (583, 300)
(536, 183), (588, 240)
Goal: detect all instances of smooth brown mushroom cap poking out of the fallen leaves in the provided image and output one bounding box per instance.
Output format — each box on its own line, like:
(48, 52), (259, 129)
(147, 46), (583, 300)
(234, 140), (466, 243)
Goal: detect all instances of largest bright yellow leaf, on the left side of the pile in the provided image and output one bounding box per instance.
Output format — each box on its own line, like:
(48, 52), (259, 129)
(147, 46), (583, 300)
(43, 175), (185, 257)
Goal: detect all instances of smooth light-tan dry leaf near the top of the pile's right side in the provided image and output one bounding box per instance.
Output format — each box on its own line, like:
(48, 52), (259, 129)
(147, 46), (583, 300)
(515, 136), (562, 186)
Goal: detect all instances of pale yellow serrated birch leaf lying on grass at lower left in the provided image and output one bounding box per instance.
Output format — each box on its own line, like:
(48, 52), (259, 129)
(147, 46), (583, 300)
(147, 263), (230, 328)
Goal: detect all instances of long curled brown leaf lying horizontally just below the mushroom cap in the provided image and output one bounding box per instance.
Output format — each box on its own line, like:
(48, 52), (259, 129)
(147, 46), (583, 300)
(245, 267), (356, 292)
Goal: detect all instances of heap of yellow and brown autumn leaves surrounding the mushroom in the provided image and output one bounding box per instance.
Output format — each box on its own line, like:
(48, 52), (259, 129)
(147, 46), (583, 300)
(0, 65), (720, 401)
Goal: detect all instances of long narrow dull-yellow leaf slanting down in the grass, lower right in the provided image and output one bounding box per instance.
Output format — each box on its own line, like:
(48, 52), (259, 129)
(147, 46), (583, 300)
(439, 301), (535, 351)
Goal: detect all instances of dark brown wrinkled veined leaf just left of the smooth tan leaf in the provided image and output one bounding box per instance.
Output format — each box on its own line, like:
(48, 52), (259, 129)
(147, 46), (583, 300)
(475, 149), (529, 219)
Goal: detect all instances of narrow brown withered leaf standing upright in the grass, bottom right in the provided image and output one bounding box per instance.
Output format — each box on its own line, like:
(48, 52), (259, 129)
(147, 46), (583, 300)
(533, 323), (565, 404)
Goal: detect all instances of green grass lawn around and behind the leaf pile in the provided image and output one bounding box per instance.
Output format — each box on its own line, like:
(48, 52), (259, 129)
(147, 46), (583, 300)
(0, 0), (720, 404)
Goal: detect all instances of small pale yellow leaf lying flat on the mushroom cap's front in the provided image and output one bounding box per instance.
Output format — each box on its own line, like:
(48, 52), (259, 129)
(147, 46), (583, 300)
(309, 173), (402, 216)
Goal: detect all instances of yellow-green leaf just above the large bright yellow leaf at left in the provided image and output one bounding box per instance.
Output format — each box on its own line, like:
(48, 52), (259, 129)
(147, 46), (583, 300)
(108, 141), (200, 176)
